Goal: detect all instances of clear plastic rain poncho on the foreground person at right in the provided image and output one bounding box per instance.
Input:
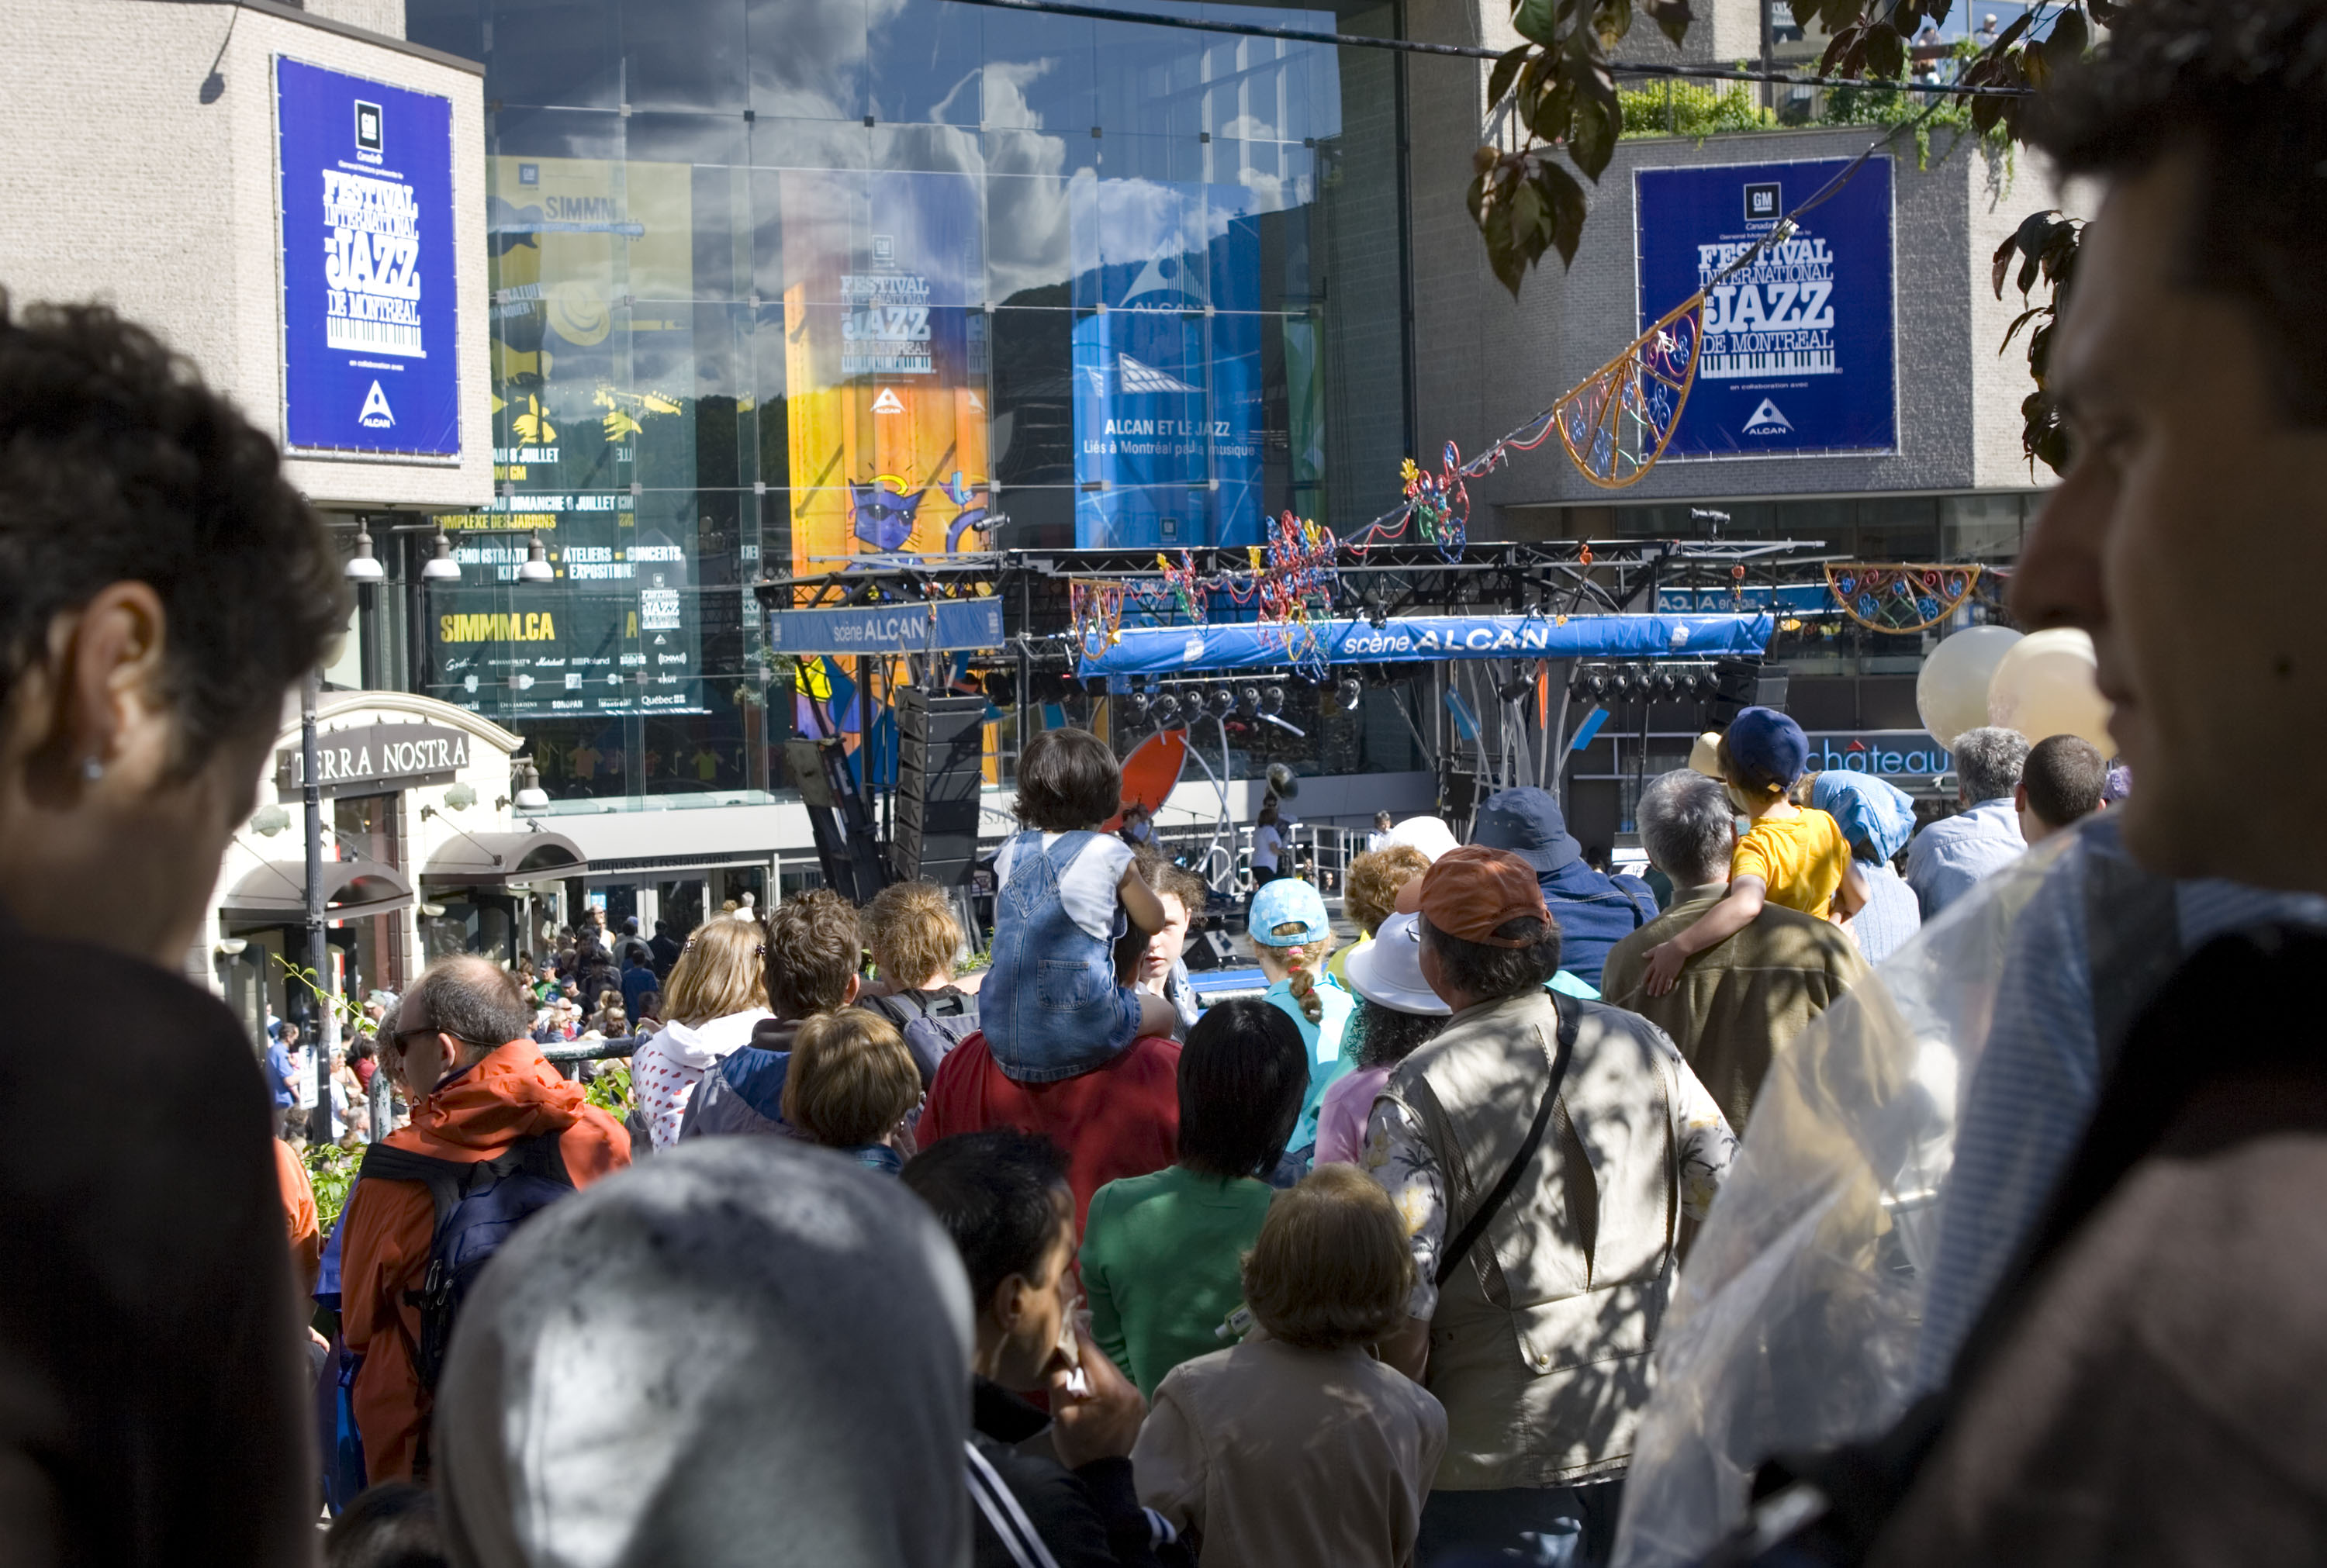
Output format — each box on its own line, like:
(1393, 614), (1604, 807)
(1615, 814), (2327, 1568)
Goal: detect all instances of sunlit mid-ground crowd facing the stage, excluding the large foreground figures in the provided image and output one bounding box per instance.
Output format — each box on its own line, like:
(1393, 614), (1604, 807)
(277, 689), (2104, 1566)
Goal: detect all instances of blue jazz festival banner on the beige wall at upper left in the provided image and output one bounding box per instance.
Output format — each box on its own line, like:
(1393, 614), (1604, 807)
(275, 56), (461, 458)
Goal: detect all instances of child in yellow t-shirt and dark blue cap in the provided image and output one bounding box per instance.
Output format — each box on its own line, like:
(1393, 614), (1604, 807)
(1643, 707), (1866, 996)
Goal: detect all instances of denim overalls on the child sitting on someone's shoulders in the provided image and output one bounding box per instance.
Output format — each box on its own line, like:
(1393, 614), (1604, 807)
(977, 833), (1140, 1084)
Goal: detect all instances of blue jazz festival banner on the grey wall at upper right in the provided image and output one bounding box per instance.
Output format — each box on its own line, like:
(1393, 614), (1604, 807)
(1631, 158), (1899, 461)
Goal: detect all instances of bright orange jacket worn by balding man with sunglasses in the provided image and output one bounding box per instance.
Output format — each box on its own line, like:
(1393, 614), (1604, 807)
(340, 1040), (631, 1484)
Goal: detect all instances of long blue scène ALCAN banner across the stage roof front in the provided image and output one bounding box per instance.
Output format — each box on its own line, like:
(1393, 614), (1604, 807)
(1080, 614), (1773, 675)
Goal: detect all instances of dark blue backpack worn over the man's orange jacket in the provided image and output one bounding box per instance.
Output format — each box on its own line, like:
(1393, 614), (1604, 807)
(363, 1133), (575, 1394)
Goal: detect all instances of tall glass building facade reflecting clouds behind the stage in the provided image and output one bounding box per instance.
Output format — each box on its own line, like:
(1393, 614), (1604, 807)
(400, 0), (1410, 803)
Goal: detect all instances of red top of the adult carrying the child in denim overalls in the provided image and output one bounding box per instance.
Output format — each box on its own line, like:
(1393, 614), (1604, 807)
(915, 1033), (1180, 1242)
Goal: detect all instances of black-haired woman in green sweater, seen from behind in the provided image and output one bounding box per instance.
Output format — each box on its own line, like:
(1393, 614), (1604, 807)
(1082, 996), (1310, 1396)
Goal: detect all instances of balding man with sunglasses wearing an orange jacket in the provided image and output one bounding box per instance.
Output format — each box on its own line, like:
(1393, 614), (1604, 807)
(340, 956), (631, 1484)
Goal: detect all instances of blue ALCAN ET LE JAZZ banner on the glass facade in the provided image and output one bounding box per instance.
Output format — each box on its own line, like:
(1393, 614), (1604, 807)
(1068, 177), (1261, 549)
